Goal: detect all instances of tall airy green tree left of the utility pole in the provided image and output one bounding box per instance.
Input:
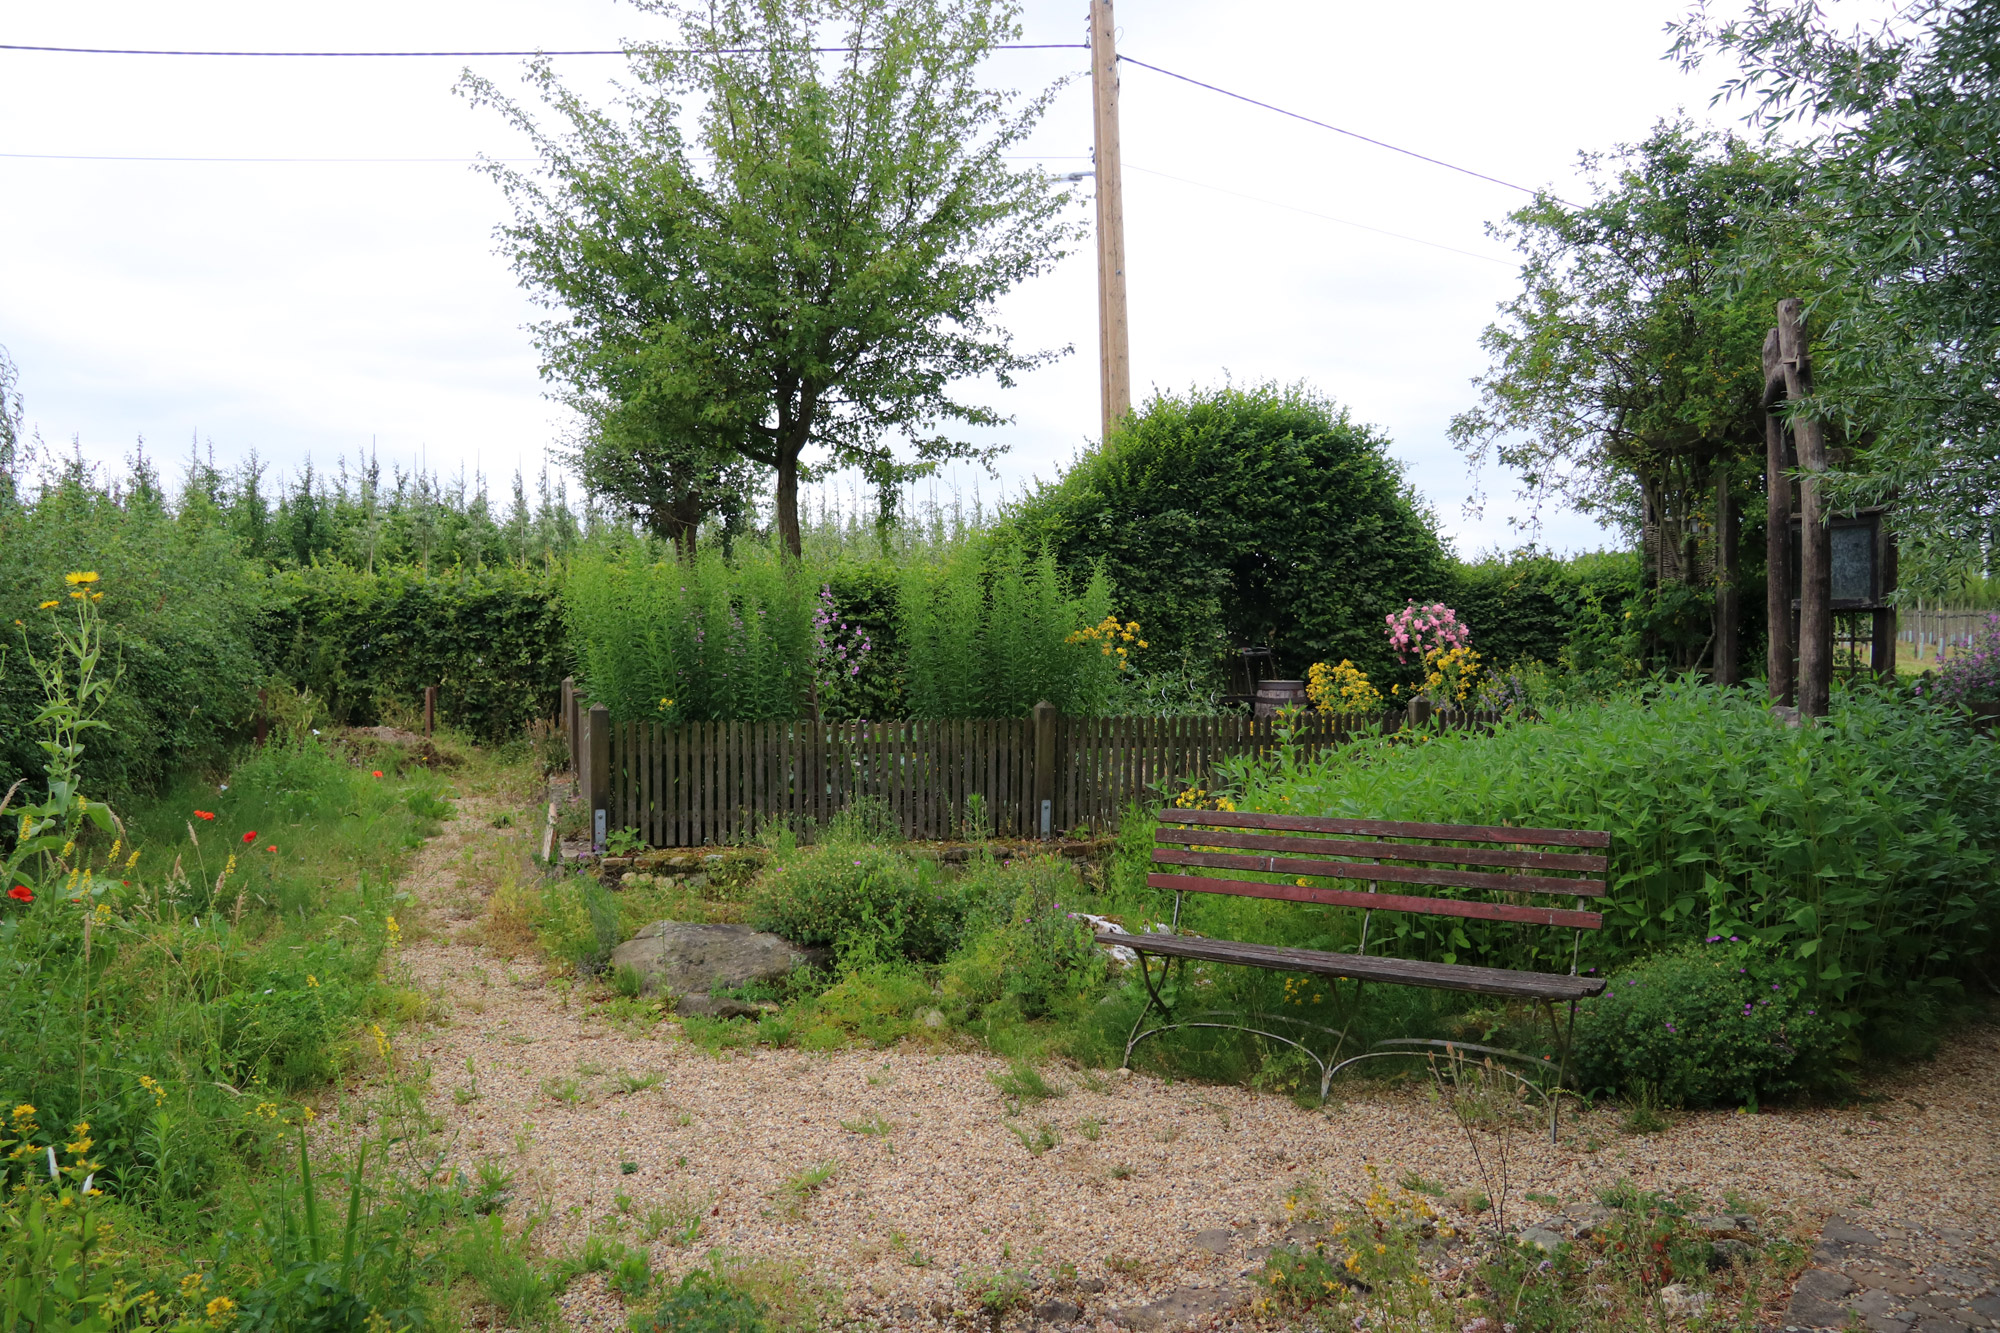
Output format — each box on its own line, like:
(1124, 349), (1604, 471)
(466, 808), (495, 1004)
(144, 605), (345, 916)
(462, 0), (1080, 556)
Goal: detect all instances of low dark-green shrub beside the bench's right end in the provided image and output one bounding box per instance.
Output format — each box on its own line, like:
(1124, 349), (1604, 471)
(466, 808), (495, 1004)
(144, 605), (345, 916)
(1576, 939), (1844, 1107)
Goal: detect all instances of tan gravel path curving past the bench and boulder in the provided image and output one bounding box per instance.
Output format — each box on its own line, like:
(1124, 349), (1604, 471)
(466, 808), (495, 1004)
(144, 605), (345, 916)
(386, 793), (2000, 1329)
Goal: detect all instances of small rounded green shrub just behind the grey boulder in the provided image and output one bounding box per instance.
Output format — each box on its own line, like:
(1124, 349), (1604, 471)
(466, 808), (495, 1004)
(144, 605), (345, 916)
(752, 843), (966, 963)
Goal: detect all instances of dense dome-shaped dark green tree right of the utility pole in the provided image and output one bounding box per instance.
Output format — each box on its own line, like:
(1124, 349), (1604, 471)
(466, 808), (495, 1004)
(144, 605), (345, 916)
(1006, 384), (1446, 679)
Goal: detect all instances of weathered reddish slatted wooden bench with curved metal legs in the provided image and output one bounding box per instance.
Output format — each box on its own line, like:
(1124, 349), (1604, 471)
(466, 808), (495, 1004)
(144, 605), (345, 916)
(1096, 811), (1610, 1104)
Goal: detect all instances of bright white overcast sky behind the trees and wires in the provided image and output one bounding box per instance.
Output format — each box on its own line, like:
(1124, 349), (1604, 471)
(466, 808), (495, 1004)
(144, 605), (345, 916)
(0, 0), (1768, 556)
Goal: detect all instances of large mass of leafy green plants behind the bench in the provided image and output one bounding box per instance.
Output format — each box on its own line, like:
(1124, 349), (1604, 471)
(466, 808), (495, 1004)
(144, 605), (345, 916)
(1232, 683), (2000, 1037)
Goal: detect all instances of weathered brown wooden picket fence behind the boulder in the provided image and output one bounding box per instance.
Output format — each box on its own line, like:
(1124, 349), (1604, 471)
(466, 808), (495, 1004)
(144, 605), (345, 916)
(566, 680), (1492, 847)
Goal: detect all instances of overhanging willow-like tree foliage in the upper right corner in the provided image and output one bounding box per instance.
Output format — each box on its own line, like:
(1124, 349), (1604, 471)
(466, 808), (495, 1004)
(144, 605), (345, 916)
(1676, 0), (2000, 568)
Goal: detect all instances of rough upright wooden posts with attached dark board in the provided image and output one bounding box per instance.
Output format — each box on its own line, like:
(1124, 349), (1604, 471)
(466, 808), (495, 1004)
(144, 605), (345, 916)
(1764, 298), (1896, 717)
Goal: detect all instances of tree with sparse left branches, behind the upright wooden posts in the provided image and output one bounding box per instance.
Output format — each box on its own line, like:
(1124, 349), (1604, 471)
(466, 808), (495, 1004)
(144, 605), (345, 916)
(1452, 122), (1792, 667)
